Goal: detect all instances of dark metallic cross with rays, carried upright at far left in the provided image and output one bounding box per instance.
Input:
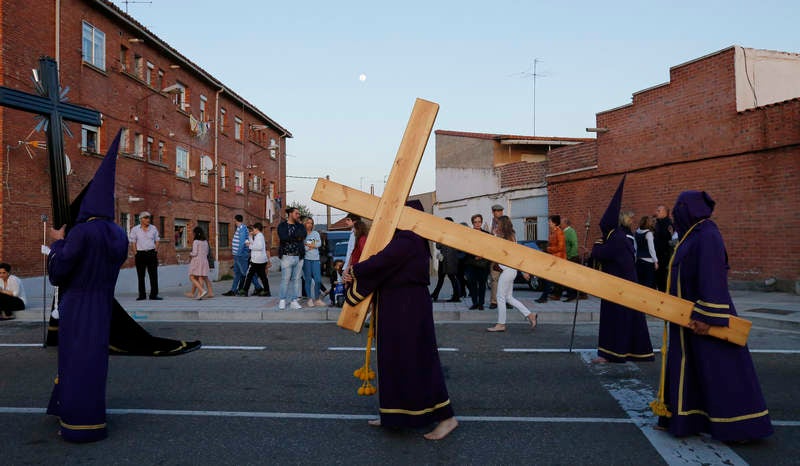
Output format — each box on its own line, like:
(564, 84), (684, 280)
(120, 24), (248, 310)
(0, 57), (102, 228)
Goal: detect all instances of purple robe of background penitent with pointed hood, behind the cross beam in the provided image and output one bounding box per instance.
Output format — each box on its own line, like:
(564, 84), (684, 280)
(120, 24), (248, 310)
(592, 227), (655, 363)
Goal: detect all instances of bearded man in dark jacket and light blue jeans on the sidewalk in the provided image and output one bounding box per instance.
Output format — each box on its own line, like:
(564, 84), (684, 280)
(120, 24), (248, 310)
(278, 207), (306, 310)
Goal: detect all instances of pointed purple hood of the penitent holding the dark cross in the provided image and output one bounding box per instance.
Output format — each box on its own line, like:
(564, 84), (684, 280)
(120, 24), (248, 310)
(75, 131), (122, 223)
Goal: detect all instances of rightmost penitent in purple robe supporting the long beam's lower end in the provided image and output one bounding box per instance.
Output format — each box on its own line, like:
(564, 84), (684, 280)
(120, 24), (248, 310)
(659, 191), (772, 442)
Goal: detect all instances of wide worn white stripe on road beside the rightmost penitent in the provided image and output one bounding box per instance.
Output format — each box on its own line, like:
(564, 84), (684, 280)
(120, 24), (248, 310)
(581, 350), (747, 466)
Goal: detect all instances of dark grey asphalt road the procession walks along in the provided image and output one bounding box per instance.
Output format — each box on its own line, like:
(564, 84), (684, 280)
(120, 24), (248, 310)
(0, 322), (800, 466)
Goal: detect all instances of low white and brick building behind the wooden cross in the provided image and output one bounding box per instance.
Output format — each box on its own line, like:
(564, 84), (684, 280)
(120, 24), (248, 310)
(433, 130), (593, 241)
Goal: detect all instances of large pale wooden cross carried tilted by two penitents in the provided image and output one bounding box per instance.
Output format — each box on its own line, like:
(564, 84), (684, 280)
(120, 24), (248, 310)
(311, 99), (752, 346)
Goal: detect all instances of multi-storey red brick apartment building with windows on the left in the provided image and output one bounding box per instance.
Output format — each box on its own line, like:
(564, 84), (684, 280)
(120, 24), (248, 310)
(0, 0), (292, 276)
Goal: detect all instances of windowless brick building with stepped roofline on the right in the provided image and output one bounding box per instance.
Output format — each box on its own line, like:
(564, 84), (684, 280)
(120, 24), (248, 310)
(547, 46), (800, 291)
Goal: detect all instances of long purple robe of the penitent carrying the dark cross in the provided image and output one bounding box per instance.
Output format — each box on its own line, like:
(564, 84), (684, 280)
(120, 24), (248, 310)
(47, 218), (128, 442)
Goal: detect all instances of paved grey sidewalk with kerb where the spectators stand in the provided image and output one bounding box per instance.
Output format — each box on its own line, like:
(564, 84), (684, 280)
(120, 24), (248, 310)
(12, 267), (800, 330)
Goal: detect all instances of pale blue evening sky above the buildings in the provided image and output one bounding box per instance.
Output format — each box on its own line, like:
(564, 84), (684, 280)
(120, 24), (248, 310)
(114, 0), (800, 222)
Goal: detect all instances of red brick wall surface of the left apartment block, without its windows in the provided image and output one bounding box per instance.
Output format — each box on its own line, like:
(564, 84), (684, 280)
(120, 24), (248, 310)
(0, 0), (285, 275)
